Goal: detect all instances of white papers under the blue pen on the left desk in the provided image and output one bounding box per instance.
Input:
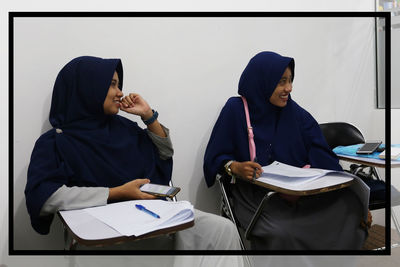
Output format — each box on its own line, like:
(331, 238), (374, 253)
(60, 199), (194, 236)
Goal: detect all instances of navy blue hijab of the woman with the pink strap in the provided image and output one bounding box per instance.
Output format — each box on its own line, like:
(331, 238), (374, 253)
(203, 52), (342, 186)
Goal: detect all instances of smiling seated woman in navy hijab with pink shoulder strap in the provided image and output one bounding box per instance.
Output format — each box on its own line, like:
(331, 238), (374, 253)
(203, 52), (366, 250)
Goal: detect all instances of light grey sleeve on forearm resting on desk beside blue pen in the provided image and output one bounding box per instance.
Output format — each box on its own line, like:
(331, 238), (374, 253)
(40, 185), (109, 216)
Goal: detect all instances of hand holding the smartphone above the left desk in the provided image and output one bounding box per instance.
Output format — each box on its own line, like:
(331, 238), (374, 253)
(108, 179), (156, 202)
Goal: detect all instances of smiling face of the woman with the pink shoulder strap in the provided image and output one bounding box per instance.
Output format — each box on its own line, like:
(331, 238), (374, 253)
(269, 67), (292, 108)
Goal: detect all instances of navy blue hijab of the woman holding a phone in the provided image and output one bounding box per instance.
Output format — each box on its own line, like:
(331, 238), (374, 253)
(25, 56), (172, 234)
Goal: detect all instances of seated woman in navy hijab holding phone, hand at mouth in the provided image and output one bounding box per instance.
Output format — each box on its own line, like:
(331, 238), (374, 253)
(25, 56), (243, 255)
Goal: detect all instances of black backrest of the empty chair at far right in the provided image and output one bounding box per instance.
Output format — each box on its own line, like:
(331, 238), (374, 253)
(319, 122), (365, 149)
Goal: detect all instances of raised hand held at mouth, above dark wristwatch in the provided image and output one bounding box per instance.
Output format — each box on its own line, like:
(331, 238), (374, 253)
(121, 93), (153, 120)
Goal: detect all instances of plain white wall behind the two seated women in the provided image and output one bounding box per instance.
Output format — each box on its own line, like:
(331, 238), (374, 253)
(0, 1), (400, 266)
